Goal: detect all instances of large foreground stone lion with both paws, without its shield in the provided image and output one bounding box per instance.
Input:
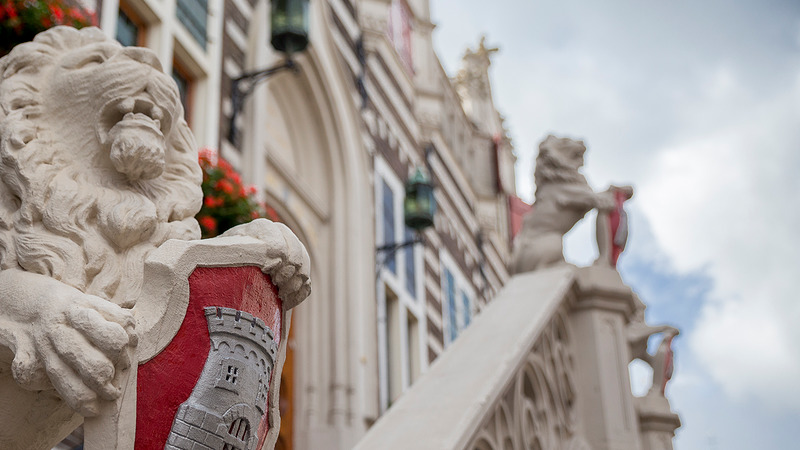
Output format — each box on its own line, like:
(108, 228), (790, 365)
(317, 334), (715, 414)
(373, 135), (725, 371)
(0, 27), (310, 449)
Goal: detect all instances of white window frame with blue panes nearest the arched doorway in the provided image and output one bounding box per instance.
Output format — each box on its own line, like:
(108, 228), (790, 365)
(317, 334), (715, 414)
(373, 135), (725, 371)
(374, 156), (428, 413)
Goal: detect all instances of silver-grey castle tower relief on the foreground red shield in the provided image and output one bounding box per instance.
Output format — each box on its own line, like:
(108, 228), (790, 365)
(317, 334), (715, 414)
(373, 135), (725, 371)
(165, 307), (278, 450)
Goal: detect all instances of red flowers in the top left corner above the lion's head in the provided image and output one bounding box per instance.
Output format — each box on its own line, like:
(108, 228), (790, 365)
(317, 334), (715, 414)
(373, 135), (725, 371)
(0, 0), (97, 56)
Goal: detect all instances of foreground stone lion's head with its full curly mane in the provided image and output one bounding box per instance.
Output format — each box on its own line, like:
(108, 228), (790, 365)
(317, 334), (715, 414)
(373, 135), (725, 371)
(0, 27), (202, 307)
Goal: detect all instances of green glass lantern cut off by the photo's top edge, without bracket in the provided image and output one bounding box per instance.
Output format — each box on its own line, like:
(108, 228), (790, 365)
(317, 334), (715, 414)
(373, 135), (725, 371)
(270, 0), (308, 54)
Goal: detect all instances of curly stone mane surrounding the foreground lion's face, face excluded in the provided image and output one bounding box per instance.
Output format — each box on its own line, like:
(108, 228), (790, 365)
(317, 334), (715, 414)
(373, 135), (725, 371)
(0, 27), (202, 307)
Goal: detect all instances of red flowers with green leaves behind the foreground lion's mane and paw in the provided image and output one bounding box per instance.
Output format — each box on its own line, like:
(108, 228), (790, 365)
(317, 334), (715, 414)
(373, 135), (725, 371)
(196, 149), (266, 238)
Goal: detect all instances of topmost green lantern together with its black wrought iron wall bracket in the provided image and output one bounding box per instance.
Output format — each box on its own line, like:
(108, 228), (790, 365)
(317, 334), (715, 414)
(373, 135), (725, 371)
(228, 0), (309, 145)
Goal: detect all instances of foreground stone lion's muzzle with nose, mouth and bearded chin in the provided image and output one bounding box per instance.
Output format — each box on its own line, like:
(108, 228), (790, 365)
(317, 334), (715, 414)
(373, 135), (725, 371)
(97, 96), (172, 181)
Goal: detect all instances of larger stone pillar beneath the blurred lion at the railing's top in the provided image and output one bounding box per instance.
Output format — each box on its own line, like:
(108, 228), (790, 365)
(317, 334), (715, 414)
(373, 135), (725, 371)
(570, 266), (642, 450)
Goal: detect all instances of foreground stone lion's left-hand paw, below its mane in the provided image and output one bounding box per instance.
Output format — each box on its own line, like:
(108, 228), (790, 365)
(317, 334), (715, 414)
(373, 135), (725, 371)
(0, 270), (137, 416)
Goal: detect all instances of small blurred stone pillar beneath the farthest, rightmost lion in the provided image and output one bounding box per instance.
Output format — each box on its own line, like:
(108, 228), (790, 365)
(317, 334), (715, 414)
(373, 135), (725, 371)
(635, 395), (681, 450)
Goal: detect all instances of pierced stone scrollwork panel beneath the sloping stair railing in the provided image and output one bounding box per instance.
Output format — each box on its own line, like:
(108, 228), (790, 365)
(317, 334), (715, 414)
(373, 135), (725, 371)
(467, 309), (587, 450)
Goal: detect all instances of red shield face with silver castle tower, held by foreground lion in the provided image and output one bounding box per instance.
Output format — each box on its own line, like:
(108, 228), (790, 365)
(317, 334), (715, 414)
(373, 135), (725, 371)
(136, 266), (282, 450)
